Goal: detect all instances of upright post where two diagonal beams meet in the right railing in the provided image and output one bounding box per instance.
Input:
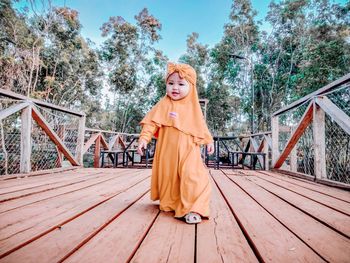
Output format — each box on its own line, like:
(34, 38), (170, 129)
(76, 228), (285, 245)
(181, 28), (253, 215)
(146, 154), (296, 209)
(313, 102), (327, 179)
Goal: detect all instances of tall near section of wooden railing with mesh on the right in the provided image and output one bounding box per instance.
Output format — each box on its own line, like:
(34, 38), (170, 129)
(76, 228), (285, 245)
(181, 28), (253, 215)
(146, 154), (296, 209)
(271, 74), (350, 186)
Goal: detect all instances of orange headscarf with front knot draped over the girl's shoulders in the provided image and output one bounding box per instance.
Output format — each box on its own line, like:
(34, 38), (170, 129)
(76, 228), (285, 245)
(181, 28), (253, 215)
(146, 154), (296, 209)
(141, 63), (213, 144)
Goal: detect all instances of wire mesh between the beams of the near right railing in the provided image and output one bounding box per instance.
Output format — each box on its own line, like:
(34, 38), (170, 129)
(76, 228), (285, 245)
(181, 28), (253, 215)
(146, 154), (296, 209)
(279, 83), (350, 183)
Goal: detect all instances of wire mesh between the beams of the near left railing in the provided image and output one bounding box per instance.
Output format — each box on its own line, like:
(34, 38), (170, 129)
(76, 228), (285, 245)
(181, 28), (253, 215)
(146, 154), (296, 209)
(0, 95), (80, 175)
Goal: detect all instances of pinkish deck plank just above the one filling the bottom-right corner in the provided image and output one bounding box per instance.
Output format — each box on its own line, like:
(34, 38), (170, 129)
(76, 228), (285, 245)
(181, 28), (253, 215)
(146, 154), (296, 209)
(242, 172), (350, 237)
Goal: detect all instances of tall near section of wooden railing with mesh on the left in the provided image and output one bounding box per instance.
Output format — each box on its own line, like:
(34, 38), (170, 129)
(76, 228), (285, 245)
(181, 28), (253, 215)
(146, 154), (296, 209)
(0, 89), (85, 174)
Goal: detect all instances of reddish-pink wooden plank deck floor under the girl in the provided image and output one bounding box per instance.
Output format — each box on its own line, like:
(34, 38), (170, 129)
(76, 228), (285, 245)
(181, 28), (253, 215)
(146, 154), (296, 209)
(0, 169), (350, 263)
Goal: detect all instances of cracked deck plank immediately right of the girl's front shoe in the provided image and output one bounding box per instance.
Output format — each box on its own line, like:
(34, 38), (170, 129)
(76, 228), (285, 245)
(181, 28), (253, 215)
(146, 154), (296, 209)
(196, 174), (258, 263)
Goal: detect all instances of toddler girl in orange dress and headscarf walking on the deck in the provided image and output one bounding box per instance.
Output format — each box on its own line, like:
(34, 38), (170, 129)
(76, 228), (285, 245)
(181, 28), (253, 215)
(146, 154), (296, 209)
(137, 63), (214, 224)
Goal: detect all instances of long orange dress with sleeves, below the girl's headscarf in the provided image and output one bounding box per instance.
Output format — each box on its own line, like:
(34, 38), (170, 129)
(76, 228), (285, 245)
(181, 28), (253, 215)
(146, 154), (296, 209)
(140, 124), (212, 217)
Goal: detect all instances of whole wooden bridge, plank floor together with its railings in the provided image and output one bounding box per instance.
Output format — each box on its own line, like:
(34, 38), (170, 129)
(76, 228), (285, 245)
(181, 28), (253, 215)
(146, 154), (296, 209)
(0, 74), (350, 263)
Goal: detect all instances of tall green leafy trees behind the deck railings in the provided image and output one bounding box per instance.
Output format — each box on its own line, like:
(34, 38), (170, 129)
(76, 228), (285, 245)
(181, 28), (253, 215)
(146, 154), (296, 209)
(0, 0), (350, 135)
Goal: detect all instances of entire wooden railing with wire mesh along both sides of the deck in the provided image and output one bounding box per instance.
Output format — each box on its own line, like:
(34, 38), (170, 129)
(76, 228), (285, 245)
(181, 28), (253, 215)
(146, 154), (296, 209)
(0, 74), (350, 187)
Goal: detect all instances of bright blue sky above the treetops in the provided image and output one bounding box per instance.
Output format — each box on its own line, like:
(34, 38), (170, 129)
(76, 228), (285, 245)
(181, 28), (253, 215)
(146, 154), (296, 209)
(15, 0), (346, 61)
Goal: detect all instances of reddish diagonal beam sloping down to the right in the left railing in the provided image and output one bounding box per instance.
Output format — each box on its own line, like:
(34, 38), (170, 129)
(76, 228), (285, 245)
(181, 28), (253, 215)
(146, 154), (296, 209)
(32, 106), (79, 166)
